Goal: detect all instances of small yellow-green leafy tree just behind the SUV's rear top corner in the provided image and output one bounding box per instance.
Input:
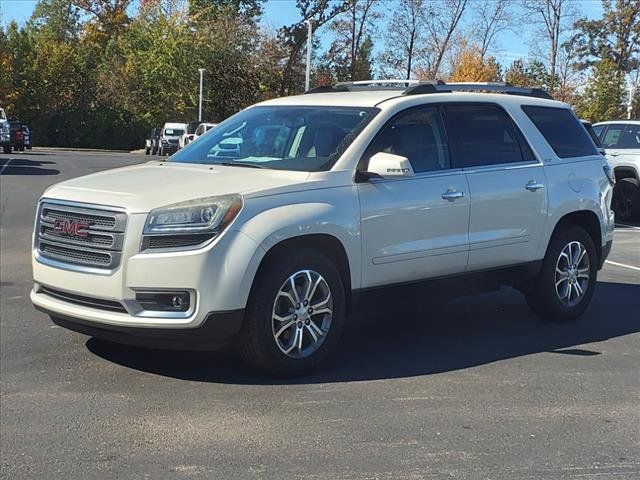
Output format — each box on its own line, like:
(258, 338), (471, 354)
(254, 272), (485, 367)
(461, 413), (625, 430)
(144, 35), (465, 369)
(577, 59), (625, 122)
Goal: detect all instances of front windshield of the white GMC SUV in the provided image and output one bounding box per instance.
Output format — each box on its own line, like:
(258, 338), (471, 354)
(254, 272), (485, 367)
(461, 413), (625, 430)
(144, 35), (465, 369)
(170, 106), (379, 172)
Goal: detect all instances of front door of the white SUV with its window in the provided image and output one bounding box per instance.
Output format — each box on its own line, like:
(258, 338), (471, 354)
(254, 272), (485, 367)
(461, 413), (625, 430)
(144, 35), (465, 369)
(358, 106), (470, 288)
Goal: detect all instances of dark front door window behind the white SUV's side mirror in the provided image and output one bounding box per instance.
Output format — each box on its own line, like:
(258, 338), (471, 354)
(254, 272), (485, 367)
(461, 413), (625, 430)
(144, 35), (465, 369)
(369, 107), (449, 173)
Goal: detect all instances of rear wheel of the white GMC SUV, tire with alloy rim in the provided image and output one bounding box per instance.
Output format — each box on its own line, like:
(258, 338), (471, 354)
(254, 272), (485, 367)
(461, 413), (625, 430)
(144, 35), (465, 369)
(525, 225), (598, 322)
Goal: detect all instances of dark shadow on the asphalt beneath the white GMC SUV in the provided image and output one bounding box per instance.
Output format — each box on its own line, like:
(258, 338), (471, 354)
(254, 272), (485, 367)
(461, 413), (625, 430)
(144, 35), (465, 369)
(86, 282), (640, 385)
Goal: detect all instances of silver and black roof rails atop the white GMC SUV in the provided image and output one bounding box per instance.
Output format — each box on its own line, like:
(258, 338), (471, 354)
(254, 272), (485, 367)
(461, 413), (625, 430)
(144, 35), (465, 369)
(305, 79), (552, 99)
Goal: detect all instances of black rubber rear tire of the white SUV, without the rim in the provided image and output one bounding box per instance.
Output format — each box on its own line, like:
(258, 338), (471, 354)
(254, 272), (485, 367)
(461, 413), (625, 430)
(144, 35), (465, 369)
(525, 225), (598, 322)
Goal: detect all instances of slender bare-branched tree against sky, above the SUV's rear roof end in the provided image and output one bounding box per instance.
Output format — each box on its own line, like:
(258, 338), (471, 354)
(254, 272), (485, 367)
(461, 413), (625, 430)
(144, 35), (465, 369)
(523, 0), (574, 95)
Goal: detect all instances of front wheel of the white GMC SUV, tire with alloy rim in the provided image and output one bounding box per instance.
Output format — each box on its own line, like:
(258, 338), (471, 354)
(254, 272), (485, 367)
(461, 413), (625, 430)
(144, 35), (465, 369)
(237, 248), (345, 378)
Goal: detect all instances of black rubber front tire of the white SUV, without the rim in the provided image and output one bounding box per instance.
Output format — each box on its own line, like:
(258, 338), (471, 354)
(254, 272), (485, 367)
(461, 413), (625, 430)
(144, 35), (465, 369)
(237, 248), (345, 378)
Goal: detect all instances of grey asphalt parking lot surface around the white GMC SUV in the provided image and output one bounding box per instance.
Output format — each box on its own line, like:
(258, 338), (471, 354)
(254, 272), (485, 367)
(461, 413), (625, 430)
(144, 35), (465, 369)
(0, 151), (640, 480)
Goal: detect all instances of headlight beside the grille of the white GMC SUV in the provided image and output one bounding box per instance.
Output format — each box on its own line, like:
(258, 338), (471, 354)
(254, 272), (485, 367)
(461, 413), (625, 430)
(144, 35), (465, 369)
(144, 194), (242, 236)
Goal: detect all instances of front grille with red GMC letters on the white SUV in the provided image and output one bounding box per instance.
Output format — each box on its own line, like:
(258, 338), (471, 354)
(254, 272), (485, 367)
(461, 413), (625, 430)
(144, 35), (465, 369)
(35, 201), (127, 270)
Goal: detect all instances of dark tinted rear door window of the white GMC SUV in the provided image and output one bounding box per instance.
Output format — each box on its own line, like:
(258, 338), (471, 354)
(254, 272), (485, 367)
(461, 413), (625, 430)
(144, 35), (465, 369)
(446, 105), (532, 167)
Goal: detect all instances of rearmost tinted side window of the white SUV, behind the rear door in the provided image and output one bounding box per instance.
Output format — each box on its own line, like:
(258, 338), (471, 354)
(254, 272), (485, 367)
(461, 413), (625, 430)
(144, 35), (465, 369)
(522, 106), (598, 158)
